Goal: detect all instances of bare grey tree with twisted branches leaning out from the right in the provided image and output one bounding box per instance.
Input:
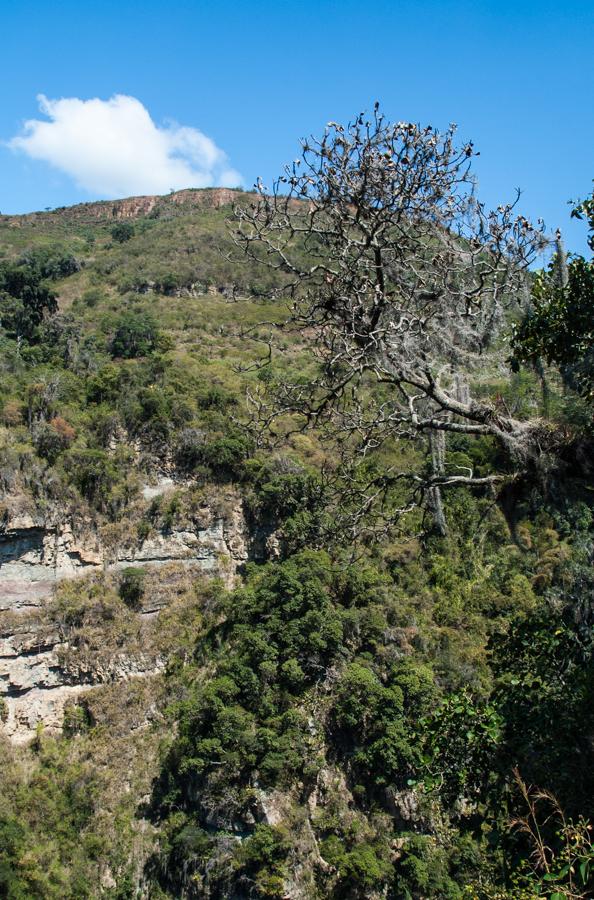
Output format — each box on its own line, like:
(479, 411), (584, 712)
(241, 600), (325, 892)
(230, 110), (545, 529)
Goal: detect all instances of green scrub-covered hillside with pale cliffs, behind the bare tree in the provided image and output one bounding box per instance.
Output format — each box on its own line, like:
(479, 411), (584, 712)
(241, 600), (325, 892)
(0, 189), (594, 900)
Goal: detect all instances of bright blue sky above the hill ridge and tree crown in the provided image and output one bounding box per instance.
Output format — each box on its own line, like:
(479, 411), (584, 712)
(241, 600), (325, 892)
(0, 0), (594, 250)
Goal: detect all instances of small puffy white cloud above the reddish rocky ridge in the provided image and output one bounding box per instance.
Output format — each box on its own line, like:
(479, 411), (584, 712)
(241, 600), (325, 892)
(8, 94), (242, 198)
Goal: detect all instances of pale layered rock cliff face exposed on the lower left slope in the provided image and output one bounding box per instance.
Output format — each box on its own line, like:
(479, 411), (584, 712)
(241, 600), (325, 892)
(0, 487), (248, 743)
